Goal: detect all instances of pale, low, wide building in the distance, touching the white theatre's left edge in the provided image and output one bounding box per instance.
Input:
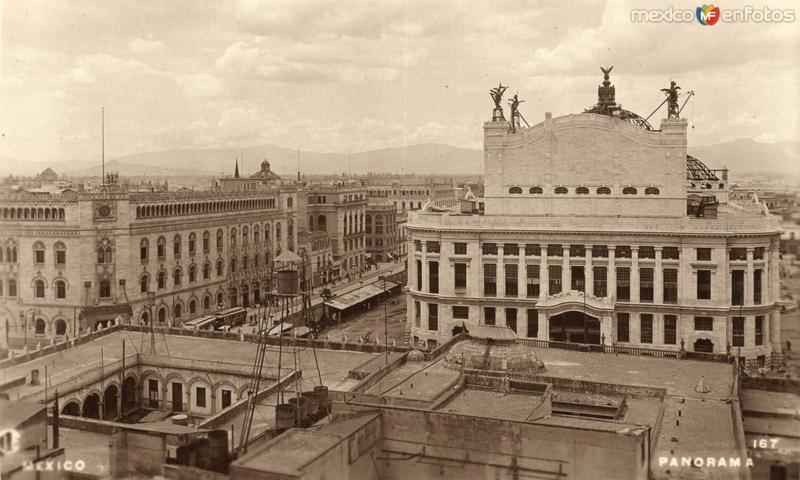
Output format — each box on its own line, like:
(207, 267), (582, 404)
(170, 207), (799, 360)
(364, 179), (458, 214)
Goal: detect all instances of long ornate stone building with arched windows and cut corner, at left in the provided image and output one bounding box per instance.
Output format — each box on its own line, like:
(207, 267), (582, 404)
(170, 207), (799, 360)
(0, 177), (296, 340)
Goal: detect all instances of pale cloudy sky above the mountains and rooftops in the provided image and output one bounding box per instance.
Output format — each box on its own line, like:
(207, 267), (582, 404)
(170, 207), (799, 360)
(0, 0), (800, 162)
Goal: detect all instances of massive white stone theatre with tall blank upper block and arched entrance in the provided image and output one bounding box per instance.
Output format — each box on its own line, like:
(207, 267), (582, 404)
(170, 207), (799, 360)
(408, 71), (781, 366)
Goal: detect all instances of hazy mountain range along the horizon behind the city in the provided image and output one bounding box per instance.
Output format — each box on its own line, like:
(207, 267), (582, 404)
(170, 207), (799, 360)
(0, 139), (800, 178)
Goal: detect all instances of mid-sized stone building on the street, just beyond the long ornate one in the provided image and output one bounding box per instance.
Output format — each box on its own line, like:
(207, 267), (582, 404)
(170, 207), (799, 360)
(298, 183), (367, 279)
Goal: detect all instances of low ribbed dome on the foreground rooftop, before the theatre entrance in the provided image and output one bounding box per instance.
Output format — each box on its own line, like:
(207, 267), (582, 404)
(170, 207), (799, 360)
(444, 325), (545, 375)
